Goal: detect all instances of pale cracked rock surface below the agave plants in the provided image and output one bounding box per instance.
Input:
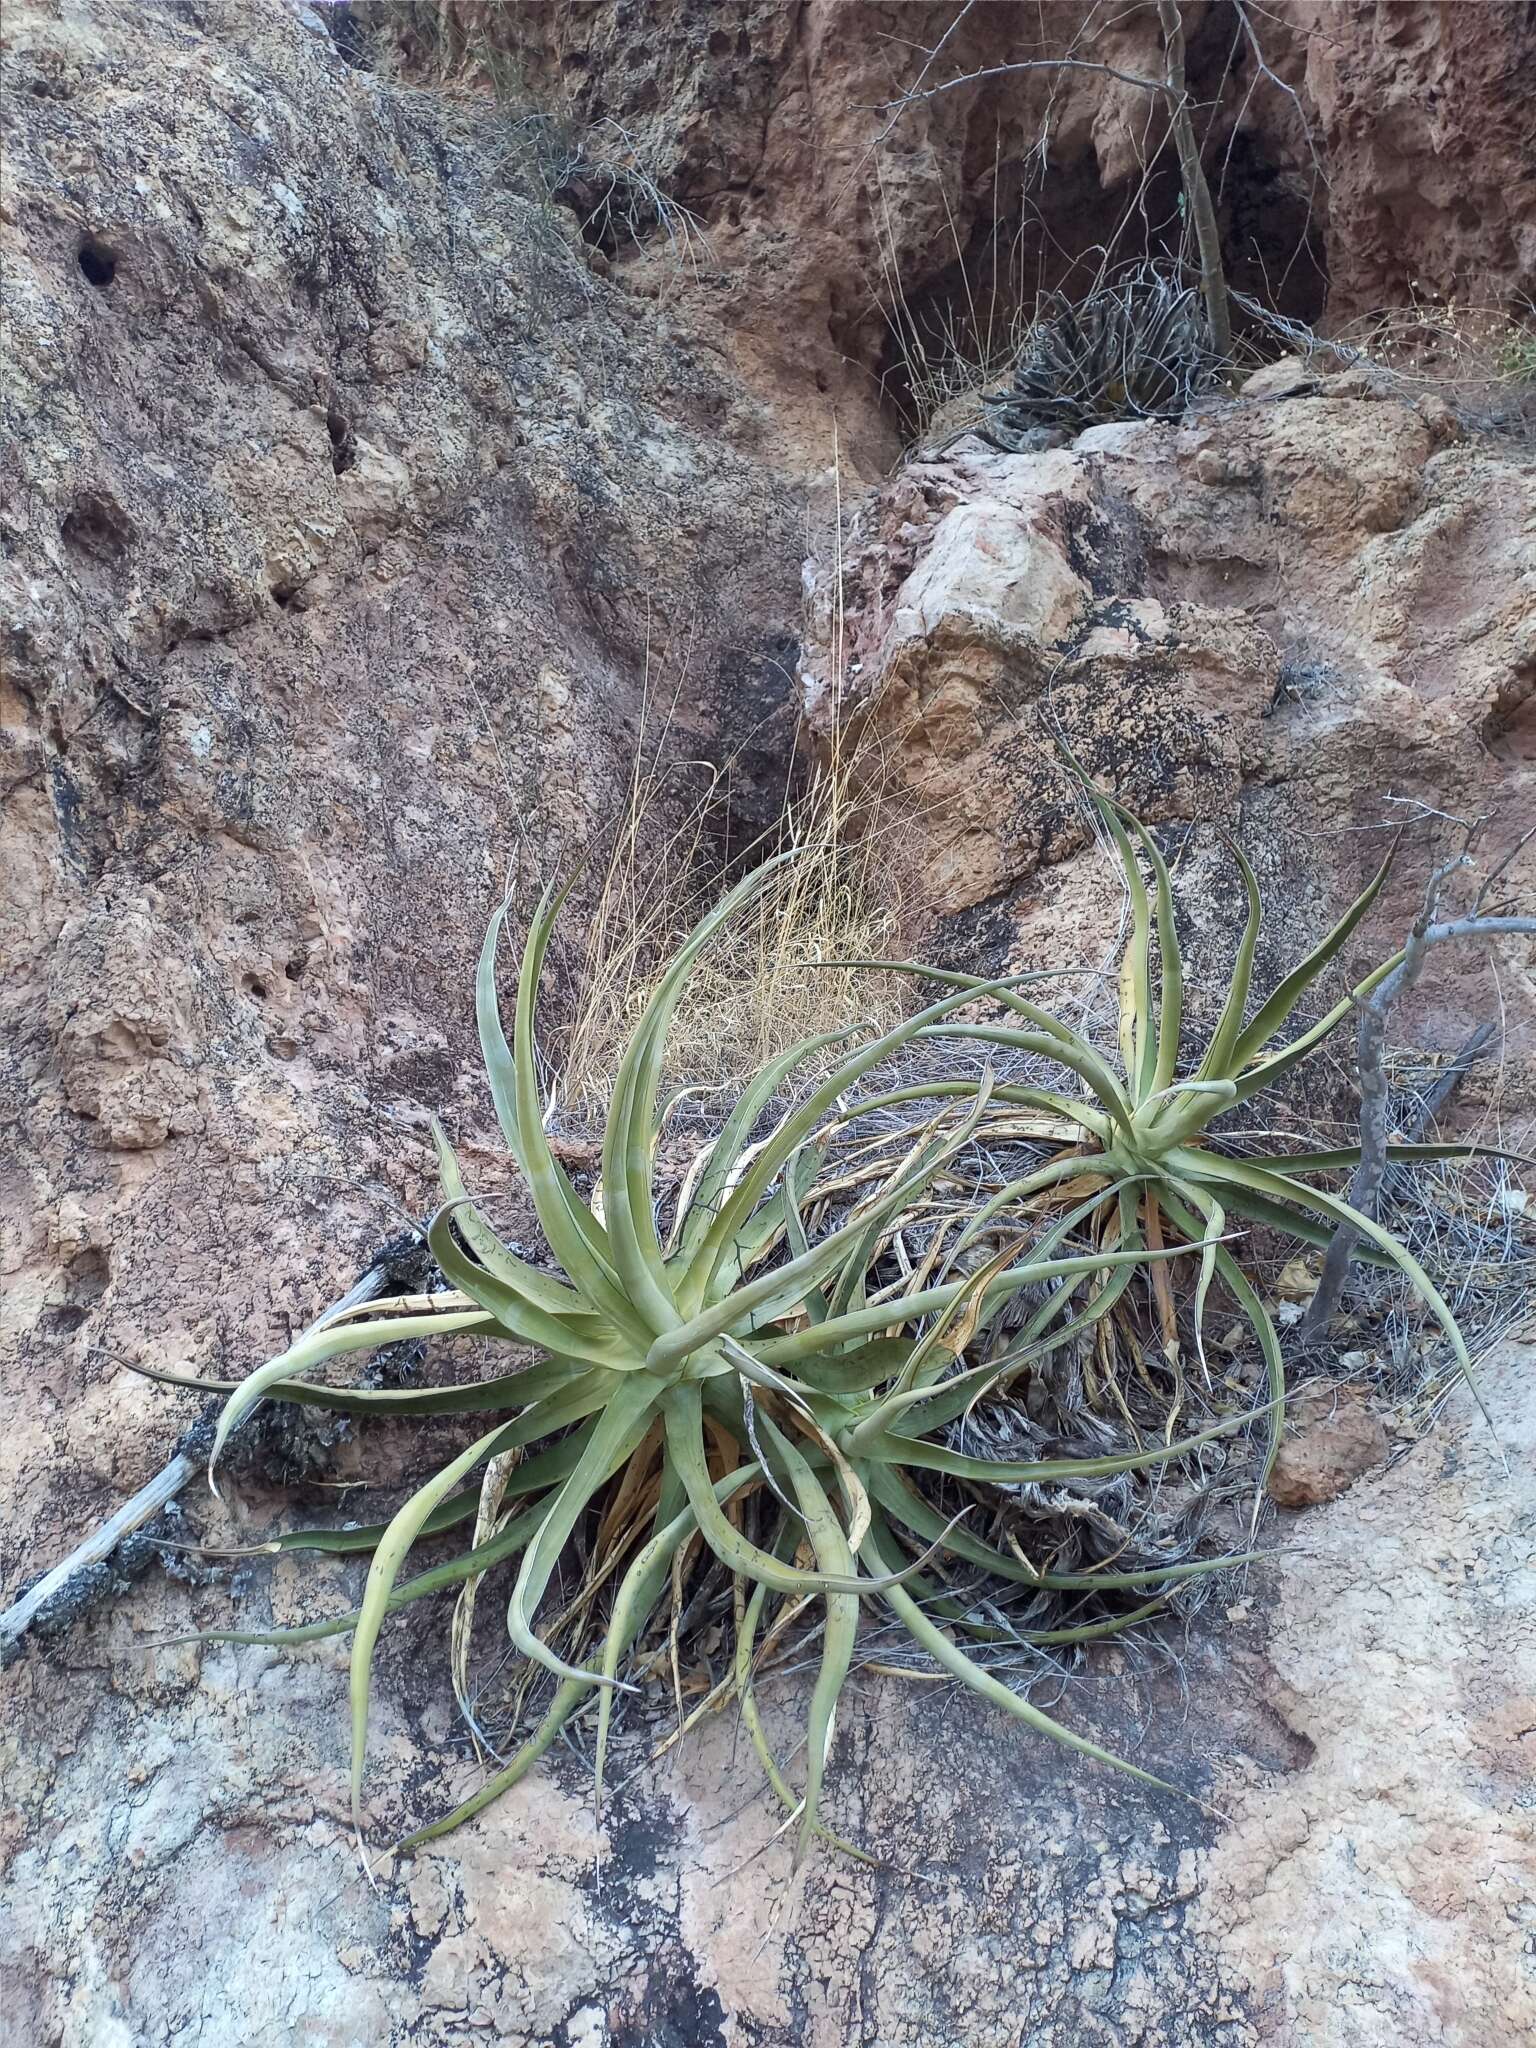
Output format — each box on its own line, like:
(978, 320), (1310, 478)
(0, 1348), (1536, 2048)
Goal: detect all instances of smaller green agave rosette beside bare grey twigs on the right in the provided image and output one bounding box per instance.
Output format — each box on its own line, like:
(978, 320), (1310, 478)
(864, 770), (1507, 1477)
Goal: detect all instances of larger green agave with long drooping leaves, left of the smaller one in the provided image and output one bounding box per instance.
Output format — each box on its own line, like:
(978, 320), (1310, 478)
(162, 847), (1241, 1853)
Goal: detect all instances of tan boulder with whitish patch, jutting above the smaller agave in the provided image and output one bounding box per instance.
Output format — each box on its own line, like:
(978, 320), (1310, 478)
(805, 362), (1536, 1110)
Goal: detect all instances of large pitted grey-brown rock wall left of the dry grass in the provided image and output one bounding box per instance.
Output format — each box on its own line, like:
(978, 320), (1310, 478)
(0, 0), (803, 1587)
